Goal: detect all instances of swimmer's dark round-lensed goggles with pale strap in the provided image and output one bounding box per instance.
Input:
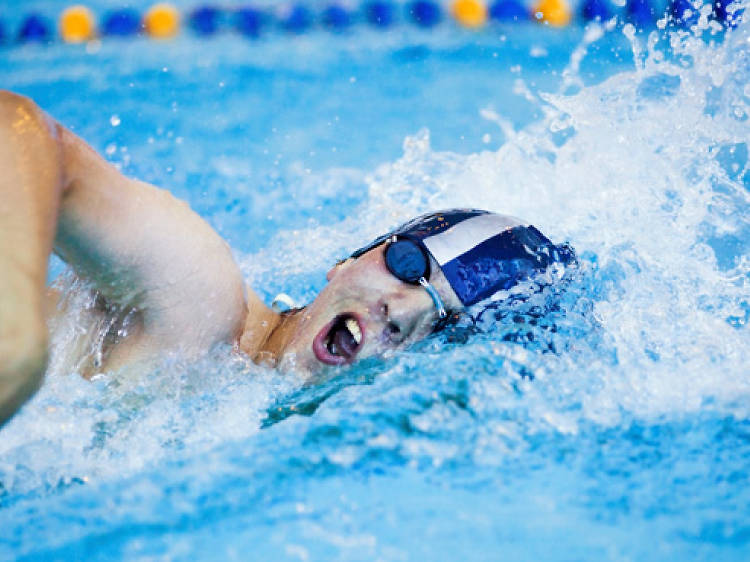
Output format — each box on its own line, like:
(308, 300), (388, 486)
(351, 234), (448, 322)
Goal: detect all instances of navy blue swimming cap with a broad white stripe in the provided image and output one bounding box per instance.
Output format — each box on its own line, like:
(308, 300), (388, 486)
(351, 209), (575, 306)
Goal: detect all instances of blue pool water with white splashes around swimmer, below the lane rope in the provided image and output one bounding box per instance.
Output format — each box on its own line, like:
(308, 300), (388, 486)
(0, 2), (750, 560)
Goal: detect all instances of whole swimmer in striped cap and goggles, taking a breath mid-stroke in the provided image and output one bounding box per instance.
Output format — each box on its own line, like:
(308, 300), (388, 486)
(0, 91), (572, 425)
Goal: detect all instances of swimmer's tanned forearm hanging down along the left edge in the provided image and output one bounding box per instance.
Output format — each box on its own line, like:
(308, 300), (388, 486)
(0, 91), (64, 425)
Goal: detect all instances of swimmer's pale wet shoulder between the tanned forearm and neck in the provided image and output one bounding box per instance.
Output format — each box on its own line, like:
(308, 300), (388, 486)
(55, 116), (251, 354)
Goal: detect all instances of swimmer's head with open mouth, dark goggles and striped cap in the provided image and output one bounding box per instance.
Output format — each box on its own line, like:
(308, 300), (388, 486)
(274, 209), (574, 372)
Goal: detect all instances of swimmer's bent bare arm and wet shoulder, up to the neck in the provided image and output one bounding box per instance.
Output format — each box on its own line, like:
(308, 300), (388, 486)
(0, 91), (251, 424)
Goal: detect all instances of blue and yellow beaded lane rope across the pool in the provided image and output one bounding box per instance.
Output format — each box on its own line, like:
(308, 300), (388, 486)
(5, 0), (742, 44)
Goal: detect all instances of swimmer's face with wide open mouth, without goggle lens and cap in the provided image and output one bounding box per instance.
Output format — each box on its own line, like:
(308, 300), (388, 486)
(281, 241), (461, 373)
